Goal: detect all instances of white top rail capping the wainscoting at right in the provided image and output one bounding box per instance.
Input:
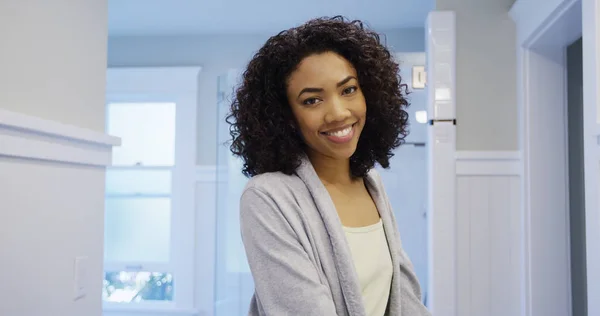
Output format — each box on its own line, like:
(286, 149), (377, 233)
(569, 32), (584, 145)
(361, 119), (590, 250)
(456, 151), (522, 176)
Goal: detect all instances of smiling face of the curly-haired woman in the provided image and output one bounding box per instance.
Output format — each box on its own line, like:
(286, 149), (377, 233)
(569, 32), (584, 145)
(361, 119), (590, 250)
(287, 52), (367, 160)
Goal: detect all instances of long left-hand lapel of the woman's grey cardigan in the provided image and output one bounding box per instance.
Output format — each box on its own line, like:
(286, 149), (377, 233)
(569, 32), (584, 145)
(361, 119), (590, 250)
(296, 157), (366, 316)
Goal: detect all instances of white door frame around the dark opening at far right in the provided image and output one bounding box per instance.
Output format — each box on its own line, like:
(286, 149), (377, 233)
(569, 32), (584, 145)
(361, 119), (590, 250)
(510, 0), (600, 316)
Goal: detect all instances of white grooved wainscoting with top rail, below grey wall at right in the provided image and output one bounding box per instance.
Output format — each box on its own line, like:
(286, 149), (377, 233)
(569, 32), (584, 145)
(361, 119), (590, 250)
(456, 152), (523, 316)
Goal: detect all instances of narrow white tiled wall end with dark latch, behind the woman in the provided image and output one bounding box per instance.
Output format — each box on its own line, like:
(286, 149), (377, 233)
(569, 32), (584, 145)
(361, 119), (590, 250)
(425, 11), (458, 316)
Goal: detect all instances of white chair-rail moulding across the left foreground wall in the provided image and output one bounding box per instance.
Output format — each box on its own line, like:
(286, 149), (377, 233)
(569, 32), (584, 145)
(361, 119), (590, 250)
(0, 109), (121, 166)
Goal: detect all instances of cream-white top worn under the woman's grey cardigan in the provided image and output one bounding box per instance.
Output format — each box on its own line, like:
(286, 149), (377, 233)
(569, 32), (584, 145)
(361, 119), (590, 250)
(344, 220), (394, 316)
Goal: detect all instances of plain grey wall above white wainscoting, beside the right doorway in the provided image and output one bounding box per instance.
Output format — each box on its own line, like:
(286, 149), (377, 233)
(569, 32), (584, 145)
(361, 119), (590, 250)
(435, 0), (519, 151)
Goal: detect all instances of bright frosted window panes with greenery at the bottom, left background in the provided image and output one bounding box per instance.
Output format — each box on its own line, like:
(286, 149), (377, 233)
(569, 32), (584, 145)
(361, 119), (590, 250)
(102, 102), (176, 303)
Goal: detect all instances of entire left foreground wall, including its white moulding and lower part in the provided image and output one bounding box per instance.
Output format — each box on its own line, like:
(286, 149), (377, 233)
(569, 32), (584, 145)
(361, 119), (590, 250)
(0, 0), (114, 316)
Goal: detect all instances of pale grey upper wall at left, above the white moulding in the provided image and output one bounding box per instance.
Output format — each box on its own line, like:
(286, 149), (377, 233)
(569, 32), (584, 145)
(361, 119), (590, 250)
(0, 0), (107, 131)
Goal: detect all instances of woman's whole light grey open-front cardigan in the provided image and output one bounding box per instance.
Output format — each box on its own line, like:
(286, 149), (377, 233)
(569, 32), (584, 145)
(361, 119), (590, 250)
(240, 158), (430, 316)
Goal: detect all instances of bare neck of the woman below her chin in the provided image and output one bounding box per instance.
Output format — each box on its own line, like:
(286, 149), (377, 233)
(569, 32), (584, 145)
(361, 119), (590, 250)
(308, 153), (356, 185)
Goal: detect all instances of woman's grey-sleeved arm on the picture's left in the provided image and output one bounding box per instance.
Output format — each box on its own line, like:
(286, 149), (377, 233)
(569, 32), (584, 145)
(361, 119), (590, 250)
(240, 188), (336, 316)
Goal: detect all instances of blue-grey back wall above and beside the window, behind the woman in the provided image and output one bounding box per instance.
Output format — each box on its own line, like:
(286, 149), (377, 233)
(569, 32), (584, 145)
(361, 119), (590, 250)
(108, 28), (425, 165)
